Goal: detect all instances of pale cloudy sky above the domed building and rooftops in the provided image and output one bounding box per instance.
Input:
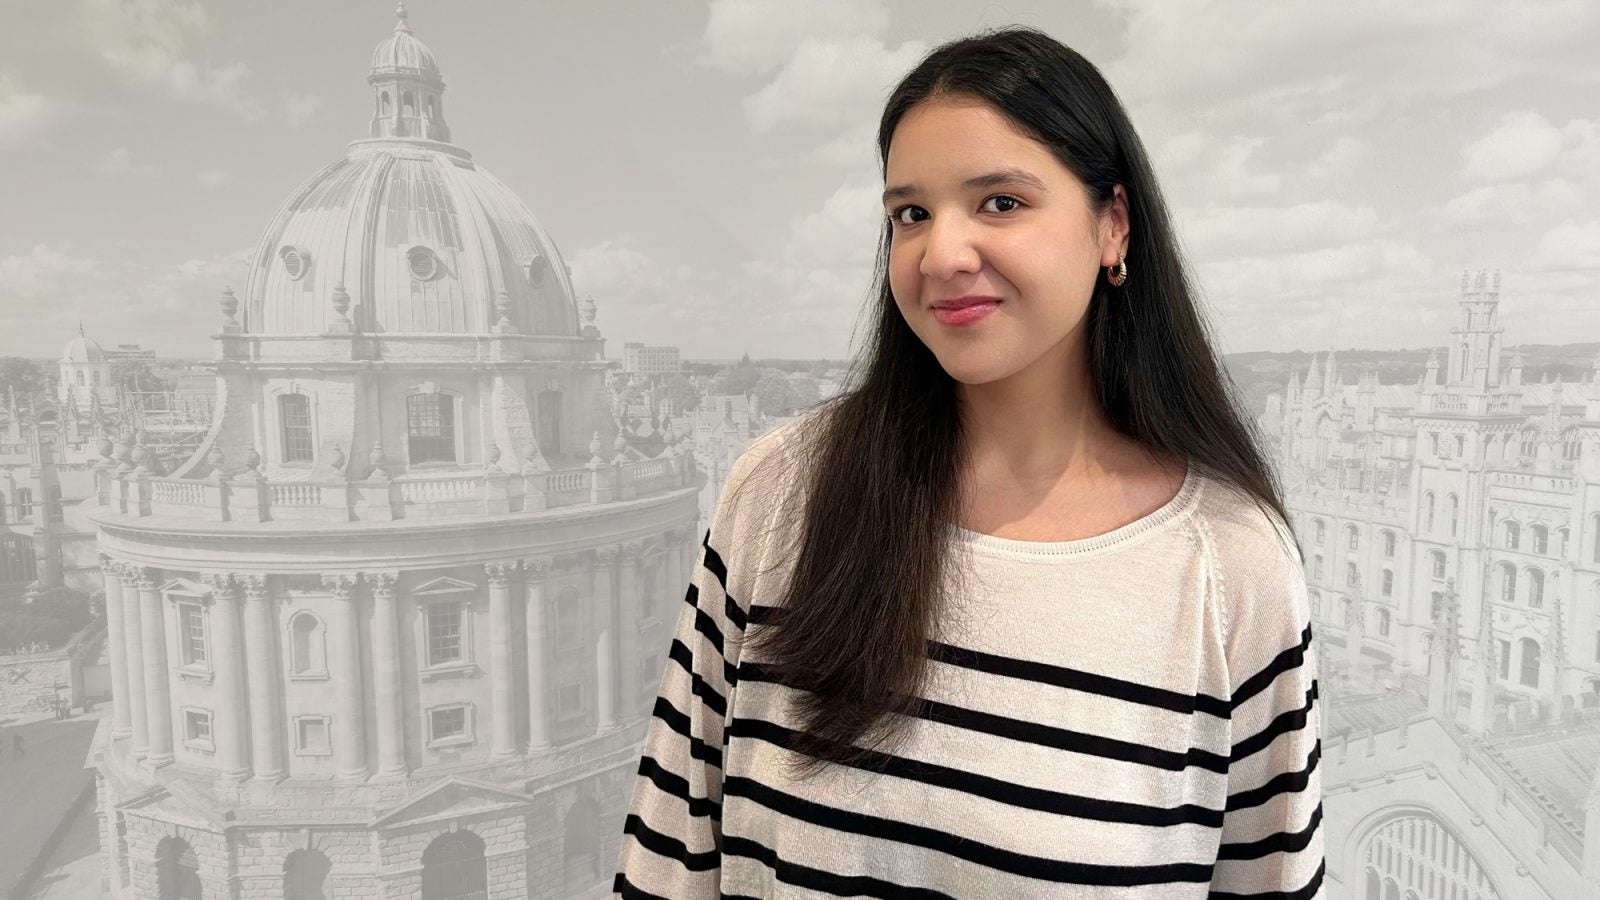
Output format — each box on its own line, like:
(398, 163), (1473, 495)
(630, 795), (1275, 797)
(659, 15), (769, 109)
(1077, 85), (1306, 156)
(0, 0), (1600, 359)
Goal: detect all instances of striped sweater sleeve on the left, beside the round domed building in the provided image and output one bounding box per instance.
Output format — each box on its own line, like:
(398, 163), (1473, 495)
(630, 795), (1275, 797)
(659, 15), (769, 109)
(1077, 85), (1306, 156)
(611, 448), (764, 900)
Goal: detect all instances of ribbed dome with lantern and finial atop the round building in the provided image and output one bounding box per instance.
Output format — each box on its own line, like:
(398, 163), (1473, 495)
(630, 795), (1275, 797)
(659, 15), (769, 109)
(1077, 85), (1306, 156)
(242, 3), (581, 336)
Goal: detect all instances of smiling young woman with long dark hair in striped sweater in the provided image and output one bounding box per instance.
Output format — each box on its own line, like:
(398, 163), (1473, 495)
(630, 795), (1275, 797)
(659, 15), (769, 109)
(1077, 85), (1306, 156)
(613, 29), (1323, 900)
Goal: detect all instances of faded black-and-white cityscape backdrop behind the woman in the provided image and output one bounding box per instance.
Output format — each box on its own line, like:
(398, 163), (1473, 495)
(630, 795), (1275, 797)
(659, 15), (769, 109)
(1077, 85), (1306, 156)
(0, 0), (1600, 900)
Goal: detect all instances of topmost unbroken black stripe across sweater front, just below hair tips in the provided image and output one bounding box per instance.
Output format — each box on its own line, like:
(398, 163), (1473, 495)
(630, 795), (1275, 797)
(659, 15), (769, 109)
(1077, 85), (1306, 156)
(723, 775), (1213, 886)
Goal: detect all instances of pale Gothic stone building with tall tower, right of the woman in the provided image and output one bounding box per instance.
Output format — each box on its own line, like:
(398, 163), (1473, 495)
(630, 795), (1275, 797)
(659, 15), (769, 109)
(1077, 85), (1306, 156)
(1266, 272), (1600, 900)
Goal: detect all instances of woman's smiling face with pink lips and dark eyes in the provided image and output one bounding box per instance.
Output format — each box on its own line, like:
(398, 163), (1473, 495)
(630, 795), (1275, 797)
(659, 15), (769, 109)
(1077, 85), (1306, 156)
(883, 98), (1138, 384)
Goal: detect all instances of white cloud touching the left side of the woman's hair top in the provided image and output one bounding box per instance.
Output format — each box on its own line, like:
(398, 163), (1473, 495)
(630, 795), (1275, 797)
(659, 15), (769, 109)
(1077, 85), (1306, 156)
(744, 35), (928, 131)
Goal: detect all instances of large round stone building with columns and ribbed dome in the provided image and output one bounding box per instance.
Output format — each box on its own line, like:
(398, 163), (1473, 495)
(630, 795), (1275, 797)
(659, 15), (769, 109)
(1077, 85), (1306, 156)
(90, 6), (704, 900)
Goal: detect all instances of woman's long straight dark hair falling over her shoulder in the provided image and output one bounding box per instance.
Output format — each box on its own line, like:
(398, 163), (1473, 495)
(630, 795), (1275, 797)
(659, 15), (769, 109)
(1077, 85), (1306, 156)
(741, 27), (1299, 777)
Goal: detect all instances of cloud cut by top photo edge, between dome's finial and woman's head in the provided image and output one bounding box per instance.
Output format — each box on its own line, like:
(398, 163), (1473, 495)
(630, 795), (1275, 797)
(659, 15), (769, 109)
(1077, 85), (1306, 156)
(701, 0), (890, 75)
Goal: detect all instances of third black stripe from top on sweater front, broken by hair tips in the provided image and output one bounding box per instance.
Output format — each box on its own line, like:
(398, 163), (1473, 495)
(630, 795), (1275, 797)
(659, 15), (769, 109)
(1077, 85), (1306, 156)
(728, 719), (1222, 828)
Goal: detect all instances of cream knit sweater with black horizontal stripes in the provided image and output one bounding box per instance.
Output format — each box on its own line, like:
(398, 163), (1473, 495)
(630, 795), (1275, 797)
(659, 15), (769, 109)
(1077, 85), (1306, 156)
(613, 423), (1325, 900)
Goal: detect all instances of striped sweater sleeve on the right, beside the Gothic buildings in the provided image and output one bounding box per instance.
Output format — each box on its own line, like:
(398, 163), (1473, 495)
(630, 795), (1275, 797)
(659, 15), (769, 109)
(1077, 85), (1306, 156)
(1211, 518), (1326, 900)
